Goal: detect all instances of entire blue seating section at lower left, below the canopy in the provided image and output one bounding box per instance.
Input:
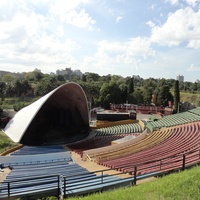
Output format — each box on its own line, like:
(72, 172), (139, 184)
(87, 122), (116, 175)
(0, 147), (127, 199)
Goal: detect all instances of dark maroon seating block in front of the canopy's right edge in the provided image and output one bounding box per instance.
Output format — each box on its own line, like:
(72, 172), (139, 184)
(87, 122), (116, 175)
(67, 135), (123, 157)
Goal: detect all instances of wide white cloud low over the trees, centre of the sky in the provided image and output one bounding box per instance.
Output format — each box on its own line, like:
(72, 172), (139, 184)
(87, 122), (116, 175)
(77, 37), (154, 75)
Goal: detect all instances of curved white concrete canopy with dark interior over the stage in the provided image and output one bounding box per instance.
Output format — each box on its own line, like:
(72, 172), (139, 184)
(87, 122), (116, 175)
(3, 83), (89, 145)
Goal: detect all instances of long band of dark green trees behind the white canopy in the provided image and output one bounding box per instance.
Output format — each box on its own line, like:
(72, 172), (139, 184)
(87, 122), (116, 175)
(0, 70), (200, 110)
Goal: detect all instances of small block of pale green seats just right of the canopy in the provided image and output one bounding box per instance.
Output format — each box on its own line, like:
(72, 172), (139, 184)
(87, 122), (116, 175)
(95, 123), (142, 136)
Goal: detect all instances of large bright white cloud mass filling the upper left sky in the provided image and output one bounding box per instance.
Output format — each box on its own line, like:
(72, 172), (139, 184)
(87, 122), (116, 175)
(0, 0), (92, 72)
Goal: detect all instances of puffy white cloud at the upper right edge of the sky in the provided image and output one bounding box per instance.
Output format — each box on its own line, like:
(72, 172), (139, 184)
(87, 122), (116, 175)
(151, 7), (200, 48)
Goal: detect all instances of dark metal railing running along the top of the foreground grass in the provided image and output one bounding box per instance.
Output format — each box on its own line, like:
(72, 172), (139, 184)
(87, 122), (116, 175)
(0, 149), (200, 199)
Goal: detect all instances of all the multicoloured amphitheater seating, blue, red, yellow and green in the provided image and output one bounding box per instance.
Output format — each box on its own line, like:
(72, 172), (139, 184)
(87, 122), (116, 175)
(0, 108), (200, 199)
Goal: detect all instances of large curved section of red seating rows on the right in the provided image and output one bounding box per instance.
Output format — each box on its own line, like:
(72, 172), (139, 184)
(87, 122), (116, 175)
(99, 123), (200, 174)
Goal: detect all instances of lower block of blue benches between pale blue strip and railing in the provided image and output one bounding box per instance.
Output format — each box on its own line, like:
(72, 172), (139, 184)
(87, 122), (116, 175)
(0, 162), (121, 198)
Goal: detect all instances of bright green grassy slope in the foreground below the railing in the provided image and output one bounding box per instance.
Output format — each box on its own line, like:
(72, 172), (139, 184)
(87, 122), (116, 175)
(63, 167), (200, 200)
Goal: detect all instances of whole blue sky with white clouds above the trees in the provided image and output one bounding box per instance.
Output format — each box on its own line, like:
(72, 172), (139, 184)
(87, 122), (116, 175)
(0, 0), (200, 82)
